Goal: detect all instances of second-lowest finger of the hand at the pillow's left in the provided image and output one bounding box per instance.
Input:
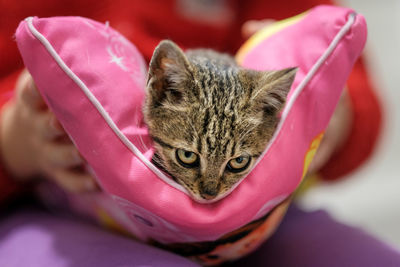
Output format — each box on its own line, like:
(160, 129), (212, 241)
(42, 142), (84, 168)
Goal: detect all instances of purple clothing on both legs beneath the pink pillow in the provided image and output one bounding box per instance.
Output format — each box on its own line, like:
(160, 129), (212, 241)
(0, 204), (400, 267)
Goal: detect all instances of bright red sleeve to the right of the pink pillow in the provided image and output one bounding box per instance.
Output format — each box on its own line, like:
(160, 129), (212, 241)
(317, 58), (383, 180)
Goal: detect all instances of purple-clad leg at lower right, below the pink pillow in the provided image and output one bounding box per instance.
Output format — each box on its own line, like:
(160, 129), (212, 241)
(234, 206), (400, 267)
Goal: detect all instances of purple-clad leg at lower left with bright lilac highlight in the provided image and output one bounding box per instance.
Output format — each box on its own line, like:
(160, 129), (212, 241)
(0, 211), (198, 267)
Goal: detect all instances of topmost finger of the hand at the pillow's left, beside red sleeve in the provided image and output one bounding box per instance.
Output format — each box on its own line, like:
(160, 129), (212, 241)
(17, 72), (46, 110)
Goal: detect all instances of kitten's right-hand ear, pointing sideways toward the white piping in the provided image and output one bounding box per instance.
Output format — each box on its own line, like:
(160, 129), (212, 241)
(252, 68), (298, 115)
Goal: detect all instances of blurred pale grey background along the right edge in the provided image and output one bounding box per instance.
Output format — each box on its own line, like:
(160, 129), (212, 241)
(300, 0), (400, 249)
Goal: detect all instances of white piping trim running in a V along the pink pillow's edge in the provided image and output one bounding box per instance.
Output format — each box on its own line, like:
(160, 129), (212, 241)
(25, 13), (356, 204)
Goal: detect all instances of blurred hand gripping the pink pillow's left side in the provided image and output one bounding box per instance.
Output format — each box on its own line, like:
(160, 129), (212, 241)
(0, 70), (97, 193)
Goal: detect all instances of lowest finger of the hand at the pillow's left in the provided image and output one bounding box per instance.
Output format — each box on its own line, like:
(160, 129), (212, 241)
(52, 169), (98, 193)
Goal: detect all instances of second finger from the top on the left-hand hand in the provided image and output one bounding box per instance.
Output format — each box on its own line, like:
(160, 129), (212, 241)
(36, 111), (66, 141)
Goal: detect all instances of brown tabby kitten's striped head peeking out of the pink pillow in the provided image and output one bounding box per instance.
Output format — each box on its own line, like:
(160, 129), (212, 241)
(144, 40), (297, 201)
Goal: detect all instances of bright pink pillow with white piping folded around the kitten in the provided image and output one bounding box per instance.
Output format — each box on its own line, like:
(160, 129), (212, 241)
(16, 6), (366, 264)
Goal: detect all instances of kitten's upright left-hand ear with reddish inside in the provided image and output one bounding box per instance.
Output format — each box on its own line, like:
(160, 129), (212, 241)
(147, 40), (191, 103)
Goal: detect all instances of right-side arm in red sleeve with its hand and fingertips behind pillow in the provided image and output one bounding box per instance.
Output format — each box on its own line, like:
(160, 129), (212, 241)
(242, 19), (382, 180)
